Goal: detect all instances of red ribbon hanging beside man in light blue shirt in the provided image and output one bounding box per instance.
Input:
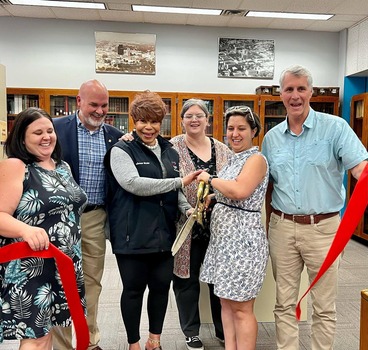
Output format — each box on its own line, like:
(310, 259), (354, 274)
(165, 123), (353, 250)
(295, 164), (368, 321)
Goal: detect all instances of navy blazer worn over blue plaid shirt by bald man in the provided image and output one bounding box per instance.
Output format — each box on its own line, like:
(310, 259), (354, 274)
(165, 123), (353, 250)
(53, 114), (123, 184)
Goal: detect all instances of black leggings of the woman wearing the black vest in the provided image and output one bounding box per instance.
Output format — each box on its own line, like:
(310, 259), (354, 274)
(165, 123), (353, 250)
(115, 252), (174, 344)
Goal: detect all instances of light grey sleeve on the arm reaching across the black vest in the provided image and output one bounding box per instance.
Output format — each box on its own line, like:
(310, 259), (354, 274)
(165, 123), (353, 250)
(110, 147), (182, 197)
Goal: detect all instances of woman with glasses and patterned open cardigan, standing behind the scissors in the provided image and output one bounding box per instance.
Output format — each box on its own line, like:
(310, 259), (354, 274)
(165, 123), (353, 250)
(170, 99), (231, 350)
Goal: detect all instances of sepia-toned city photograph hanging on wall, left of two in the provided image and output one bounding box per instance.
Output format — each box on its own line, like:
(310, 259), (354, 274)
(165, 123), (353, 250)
(95, 32), (156, 75)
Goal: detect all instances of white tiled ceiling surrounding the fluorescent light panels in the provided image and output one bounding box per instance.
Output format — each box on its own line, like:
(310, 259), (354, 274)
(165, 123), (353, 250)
(0, 0), (368, 32)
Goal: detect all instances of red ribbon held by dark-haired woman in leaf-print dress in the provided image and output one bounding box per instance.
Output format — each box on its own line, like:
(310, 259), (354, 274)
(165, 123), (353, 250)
(0, 242), (89, 350)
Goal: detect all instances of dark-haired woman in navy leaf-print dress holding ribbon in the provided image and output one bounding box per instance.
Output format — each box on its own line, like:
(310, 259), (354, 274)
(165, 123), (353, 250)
(0, 108), (87, 350)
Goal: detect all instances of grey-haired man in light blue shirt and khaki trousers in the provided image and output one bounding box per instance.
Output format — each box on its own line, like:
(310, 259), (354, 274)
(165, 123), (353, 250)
(262, 66), (368, 350)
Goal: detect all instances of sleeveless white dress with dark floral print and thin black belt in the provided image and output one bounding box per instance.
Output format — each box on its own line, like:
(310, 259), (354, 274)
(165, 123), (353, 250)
(200, 147), (269, 301)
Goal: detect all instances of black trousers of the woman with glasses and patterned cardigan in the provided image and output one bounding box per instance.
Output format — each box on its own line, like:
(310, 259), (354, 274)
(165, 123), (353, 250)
(173, 239), (224, 339)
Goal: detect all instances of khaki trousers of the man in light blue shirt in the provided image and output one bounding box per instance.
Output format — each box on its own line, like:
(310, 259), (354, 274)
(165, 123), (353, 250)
(268, 213), (340, 350)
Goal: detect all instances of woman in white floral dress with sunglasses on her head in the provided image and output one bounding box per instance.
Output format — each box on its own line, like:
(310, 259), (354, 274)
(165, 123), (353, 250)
(198, 106), (268, 350)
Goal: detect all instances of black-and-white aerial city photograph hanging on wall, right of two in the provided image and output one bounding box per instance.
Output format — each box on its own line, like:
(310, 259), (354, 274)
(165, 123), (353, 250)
(218, 38), (275, 79)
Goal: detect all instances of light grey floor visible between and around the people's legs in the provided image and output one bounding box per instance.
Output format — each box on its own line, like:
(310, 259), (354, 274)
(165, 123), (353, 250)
(0, 240), (368, 350)
